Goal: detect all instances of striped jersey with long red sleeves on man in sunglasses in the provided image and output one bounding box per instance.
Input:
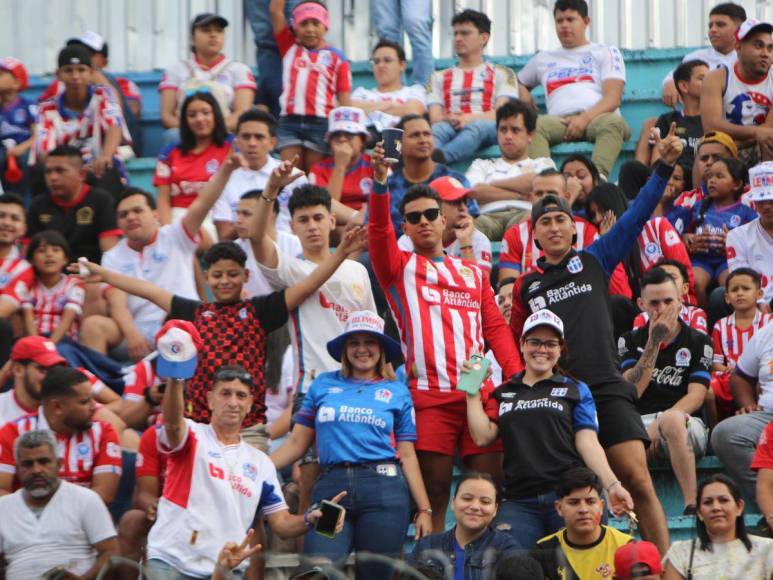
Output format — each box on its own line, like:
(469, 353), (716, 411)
(368, 183), (519, 410)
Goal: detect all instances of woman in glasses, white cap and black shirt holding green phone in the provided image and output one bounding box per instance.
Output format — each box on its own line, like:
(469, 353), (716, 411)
(467, 310), (633, 549)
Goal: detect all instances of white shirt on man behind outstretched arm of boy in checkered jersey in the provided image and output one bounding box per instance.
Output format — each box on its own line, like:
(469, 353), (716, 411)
(102, 222), (199, 341)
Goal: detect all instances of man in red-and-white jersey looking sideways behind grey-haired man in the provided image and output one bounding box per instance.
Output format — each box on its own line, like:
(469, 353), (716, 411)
(0, 367), (121, 503)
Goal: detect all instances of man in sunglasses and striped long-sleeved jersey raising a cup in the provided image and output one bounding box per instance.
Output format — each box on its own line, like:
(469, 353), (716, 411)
(368, 145), (521, 531)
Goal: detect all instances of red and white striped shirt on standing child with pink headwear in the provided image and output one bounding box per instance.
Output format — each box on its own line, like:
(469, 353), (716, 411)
(276, 27), (352, 119)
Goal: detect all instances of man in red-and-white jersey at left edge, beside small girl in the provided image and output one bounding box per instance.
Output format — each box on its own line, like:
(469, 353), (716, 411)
(0, 193), (35, 322)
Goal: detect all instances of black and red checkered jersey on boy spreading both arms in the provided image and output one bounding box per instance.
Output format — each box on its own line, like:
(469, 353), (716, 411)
(169, 290), (288, 427)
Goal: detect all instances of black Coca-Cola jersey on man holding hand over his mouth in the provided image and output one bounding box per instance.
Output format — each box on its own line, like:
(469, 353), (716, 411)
(618, 320), (714, 415)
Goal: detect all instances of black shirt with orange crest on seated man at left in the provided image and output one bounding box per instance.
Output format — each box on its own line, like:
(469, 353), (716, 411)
(27, 185), (121, 263)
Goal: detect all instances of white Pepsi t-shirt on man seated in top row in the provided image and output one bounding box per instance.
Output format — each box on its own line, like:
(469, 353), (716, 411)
(518, 42), (625, 117)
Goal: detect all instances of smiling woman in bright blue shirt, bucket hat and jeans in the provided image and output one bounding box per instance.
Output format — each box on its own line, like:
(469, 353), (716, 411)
(271, 311), (432, 579)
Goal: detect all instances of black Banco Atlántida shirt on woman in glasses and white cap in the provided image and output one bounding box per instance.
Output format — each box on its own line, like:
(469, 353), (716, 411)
(486, 374), (598, 499)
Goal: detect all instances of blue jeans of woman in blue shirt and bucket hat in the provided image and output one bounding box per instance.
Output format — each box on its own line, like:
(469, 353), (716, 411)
(304, 464), (411, 580)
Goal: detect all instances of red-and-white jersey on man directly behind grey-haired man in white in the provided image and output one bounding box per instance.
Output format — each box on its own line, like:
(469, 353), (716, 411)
(0, 407), (122, 489)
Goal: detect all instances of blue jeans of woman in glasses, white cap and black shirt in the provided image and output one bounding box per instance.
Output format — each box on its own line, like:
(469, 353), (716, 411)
(494, 492), (564, 550)
